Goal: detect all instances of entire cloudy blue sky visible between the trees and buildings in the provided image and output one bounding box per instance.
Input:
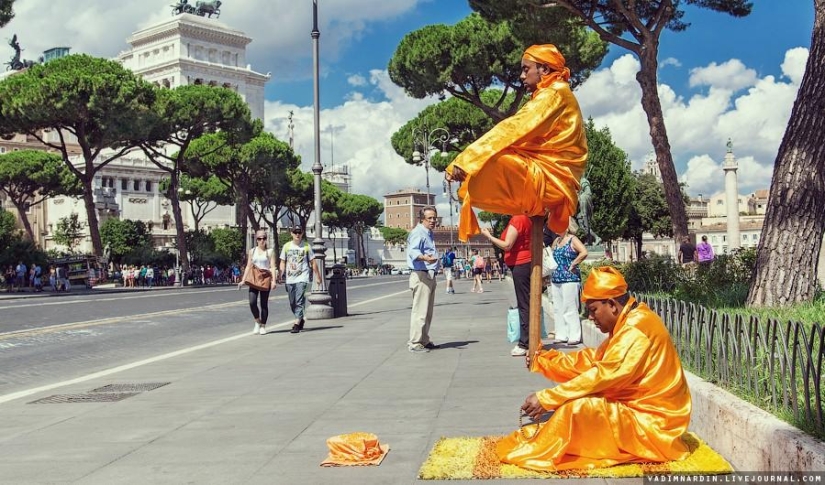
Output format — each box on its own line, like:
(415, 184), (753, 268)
(0, 0), (814, 204)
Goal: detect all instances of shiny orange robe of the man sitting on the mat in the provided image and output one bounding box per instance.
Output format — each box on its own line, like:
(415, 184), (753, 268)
(497, 298), (691, 471)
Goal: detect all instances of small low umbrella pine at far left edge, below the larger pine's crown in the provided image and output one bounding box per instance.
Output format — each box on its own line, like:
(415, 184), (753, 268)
(0, 150), (83, 244)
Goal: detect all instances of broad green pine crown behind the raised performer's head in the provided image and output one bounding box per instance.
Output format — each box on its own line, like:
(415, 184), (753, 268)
(388, 12), (607, 122)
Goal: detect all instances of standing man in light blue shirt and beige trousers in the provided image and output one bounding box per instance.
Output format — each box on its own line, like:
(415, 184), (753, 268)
(407, 206), (439, 353)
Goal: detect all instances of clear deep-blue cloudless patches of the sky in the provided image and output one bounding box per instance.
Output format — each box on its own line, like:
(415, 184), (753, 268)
(267, 0), (813, 107)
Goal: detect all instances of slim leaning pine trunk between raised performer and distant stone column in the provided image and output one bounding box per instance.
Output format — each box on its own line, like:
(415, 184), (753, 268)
(636, 48), (688, 243)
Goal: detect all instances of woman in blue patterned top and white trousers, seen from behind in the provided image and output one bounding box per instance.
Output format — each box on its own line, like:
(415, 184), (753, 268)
(550, 217), (587, 346)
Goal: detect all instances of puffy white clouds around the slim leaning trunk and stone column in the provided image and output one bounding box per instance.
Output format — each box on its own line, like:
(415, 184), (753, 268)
(576, 48), (808, 194)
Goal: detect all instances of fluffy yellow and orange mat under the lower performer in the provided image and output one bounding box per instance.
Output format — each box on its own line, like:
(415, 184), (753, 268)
(418, 433), (733, 480)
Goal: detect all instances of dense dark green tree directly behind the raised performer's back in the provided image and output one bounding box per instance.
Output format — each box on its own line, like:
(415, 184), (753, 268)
(585, 119), (636, 245)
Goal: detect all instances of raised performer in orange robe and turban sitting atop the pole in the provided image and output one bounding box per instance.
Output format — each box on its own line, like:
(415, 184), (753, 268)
(446, 44), (587, 241)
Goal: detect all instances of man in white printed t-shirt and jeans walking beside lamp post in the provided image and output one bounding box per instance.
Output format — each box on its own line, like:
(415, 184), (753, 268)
(281, 227), (321, 333)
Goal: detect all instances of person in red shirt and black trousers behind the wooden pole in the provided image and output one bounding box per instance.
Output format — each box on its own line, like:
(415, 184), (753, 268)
(481, 214), (533, 357)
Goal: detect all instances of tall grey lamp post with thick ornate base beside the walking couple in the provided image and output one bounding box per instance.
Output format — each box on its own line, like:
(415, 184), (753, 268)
(306, 0), (334, 320)
